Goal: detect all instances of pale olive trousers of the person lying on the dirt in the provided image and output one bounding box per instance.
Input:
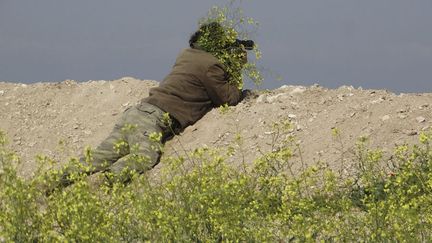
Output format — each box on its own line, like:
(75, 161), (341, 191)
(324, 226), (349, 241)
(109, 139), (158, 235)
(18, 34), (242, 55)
(63, 103), (173, 185)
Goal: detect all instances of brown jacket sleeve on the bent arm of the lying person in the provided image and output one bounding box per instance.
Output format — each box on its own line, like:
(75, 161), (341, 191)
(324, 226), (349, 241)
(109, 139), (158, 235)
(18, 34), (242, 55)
(203, 64), (241, 106)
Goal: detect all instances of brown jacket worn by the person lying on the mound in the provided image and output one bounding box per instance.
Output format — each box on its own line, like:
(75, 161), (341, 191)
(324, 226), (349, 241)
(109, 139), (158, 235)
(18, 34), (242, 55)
(141, 48), (241, 129)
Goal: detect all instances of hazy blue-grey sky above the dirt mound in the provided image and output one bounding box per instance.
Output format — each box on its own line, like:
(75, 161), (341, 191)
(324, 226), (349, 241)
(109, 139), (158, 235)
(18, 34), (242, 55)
(0, 0), (432, 92)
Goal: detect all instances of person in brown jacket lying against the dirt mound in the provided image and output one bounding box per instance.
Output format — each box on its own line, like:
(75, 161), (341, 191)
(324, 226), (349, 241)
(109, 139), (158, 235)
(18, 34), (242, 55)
(62, 22), (253, 186)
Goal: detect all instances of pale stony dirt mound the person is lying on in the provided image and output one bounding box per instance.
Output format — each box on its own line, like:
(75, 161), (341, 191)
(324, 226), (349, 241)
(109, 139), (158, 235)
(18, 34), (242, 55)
(0, 77), (432, 175)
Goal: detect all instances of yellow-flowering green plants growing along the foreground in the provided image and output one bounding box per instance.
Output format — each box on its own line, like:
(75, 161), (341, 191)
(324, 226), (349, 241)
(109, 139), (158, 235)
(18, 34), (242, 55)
(0, 125), (432, 242)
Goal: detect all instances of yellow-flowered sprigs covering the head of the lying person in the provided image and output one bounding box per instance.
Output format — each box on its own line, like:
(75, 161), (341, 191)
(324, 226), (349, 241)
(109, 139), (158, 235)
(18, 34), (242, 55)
(197, 1), (263, 89)
